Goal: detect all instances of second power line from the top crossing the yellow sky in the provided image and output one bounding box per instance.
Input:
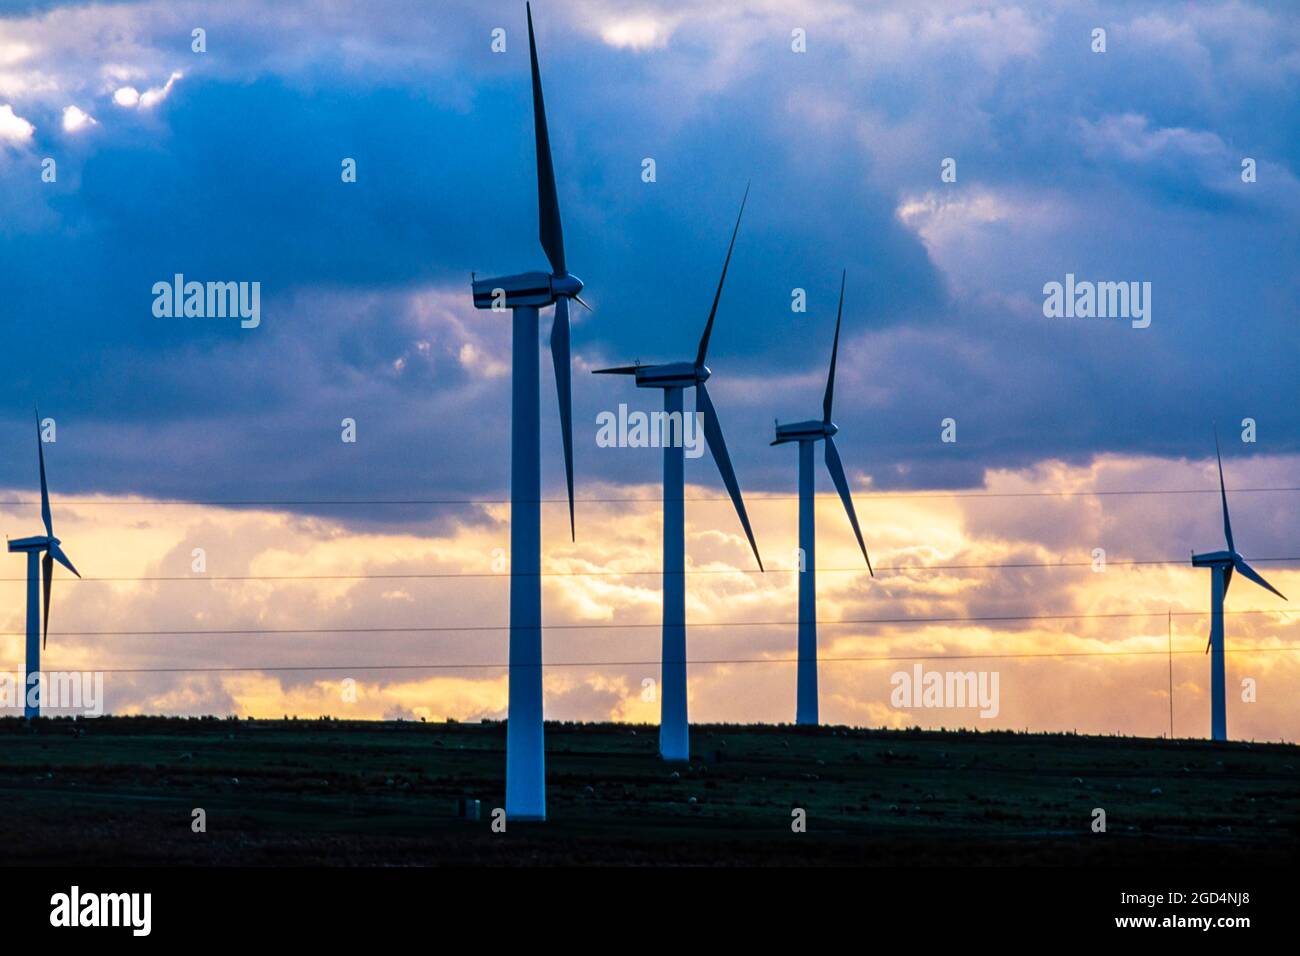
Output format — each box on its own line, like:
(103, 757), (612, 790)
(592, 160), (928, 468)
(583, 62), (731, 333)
(0, 555), (1300, 587)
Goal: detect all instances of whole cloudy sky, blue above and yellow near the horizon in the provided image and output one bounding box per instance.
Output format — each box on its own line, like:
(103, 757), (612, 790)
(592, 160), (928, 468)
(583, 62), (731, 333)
(0, 0), (1300, 740)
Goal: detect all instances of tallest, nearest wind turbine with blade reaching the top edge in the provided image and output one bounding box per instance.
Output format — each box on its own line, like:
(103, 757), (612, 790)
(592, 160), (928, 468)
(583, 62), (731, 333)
(473, 4), (585, 819)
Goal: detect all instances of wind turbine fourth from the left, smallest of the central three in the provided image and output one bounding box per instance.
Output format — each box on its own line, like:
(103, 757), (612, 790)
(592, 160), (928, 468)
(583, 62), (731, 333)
(772, 273), (875, 724)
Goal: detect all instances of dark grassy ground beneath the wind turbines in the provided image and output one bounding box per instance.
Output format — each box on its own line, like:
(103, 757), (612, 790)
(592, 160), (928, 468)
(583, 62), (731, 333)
(0, 717), (1300, 865)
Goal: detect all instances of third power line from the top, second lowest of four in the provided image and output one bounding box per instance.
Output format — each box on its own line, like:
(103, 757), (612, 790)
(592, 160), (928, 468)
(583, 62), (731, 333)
(0, 610), (1300, 637)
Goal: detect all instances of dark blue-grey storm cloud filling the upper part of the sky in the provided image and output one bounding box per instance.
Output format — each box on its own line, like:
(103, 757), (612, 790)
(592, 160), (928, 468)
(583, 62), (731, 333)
(0, 3), (1300, 522)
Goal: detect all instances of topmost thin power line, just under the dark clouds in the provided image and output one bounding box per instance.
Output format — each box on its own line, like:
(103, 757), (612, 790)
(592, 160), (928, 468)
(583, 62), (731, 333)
(0, 485), (1300, 507)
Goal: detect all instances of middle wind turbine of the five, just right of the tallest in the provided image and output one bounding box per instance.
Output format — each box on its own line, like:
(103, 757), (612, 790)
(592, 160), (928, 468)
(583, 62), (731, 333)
(595, 186), (763, 761)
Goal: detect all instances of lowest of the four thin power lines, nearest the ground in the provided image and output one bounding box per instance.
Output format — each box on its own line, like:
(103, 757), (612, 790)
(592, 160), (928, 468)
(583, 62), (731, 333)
(45, 644), (1300, 674)
